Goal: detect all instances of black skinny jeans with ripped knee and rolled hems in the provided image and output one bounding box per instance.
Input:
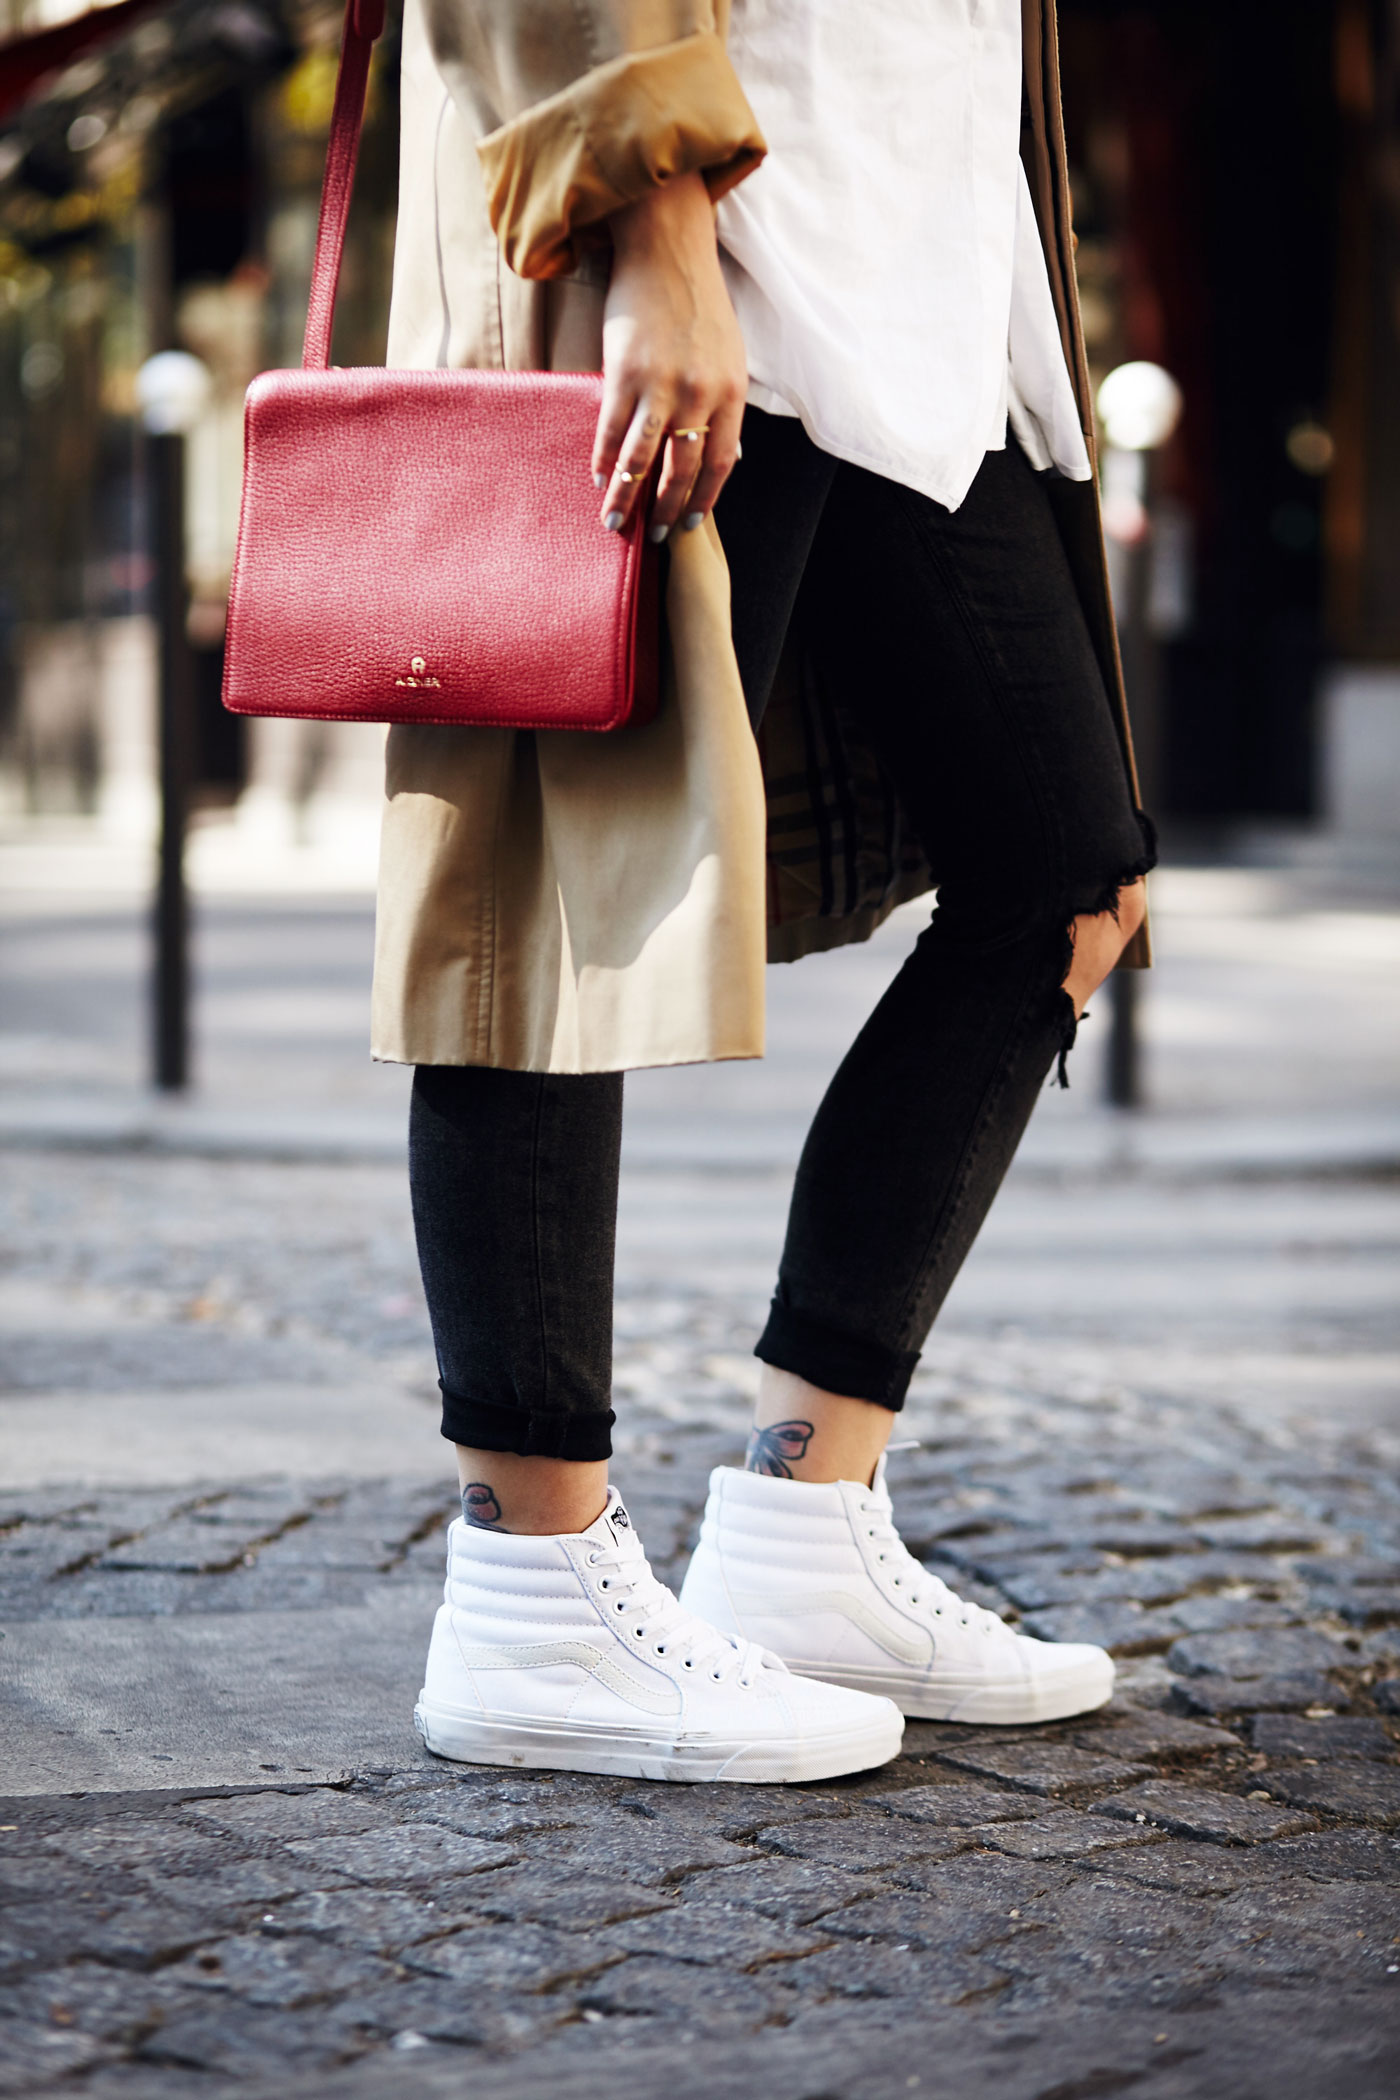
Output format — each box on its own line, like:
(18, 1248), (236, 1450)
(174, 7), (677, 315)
(409, 410), (1152, 1460)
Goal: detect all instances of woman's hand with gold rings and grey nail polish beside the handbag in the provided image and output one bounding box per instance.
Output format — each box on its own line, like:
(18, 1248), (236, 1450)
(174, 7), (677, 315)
(594, 174), (747, 540)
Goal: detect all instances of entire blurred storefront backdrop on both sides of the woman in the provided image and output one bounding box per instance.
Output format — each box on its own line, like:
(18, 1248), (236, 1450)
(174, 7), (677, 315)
(0, 0), (1400, 842)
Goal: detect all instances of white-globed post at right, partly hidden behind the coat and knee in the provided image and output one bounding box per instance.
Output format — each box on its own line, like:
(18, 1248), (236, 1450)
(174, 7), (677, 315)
(1098, 361), (1182, 1109)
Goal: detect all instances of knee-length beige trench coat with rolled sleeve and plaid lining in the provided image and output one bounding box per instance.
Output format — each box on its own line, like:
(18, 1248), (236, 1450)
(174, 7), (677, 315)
(374, 0), (1146, 1071)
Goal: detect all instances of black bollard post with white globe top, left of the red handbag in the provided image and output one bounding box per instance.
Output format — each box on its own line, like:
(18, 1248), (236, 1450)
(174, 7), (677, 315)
(136, 351), (210, 1092)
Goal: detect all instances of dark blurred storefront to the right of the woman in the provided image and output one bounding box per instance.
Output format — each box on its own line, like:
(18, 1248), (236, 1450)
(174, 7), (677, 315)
(1060, 0), (1400, 842)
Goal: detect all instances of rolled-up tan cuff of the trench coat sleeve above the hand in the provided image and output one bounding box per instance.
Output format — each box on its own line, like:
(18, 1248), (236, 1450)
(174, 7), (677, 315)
(476, 29), (766, 277)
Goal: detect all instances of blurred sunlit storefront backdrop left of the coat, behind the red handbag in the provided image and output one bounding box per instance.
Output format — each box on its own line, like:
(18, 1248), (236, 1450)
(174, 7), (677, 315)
(0, 0), (397, 852)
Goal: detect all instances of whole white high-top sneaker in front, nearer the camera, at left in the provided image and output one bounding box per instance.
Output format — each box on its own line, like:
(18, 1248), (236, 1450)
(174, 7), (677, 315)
(413, 1489), (905, 1783)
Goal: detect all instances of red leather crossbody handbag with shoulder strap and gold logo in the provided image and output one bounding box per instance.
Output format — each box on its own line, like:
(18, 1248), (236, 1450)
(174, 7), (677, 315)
(225, 0), (659, 729)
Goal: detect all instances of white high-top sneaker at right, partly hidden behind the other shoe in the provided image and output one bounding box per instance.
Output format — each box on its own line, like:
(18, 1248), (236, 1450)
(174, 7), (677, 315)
(680, 1460), (1112, 1724)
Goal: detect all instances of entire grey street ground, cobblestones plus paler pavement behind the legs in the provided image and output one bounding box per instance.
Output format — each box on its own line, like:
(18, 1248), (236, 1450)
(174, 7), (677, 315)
(0, 844), (1400, 2100)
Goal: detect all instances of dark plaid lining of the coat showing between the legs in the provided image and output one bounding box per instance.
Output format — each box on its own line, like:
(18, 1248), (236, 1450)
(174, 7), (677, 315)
(758, 647), (932, 962)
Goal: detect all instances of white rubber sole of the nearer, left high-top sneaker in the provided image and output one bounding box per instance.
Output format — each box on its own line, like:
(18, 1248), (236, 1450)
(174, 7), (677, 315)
(413, 1693), (905, 1785)
